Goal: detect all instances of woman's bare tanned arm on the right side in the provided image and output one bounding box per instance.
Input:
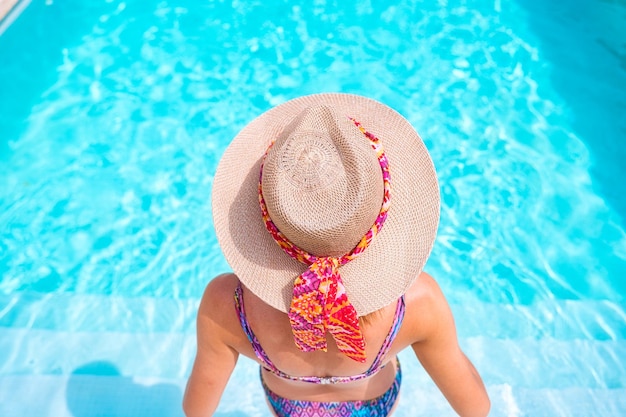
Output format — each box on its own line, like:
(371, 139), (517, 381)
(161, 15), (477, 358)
(412, 273), (491, 417)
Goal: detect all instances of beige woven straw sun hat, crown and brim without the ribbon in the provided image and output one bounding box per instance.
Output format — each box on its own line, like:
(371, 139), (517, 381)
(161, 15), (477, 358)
(212, 93), (439, 316)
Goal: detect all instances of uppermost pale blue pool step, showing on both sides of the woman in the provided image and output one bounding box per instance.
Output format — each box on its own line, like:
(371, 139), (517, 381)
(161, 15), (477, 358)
(0, 292), (626, 340)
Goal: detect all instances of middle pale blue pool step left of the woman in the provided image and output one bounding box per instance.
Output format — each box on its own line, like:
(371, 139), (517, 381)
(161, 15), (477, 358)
(0, 328), (196, 378)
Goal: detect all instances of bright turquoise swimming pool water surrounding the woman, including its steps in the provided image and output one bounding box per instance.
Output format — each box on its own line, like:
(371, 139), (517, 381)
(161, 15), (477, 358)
(0, 0), (626, 417)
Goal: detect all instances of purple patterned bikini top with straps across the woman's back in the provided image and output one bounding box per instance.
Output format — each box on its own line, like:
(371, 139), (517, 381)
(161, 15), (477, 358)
(235, 283), (405, 384)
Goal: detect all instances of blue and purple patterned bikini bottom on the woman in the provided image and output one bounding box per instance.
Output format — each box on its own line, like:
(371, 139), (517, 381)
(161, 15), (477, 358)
(261, 361), (402, 417)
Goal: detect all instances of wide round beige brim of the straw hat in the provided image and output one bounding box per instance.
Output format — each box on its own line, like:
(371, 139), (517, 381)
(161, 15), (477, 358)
(212, 93), (440, 316)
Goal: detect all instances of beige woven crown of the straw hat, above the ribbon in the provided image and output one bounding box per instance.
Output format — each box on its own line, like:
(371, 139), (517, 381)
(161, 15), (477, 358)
(262, 106), (384, 256)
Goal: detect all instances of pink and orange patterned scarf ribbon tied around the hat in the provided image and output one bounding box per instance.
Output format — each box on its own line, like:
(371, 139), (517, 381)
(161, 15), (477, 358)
(259, 117), (390, 362)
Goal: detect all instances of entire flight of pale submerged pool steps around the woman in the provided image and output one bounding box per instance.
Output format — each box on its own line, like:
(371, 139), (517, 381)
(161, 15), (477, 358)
(0, 292), (626, 417)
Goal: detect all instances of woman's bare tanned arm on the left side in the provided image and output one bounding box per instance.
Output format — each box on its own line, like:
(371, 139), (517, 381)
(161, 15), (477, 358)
(183, 275), (239, 417)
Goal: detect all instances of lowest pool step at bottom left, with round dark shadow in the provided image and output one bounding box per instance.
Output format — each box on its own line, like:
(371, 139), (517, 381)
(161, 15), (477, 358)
(0, 358), (260, 417)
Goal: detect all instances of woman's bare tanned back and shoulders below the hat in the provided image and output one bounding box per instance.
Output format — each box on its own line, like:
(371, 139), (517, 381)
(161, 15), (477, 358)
(190, 273), (458, 401)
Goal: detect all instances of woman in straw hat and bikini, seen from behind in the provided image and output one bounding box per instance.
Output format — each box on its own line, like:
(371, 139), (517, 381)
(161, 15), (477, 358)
(183, 94), (490, 417)
